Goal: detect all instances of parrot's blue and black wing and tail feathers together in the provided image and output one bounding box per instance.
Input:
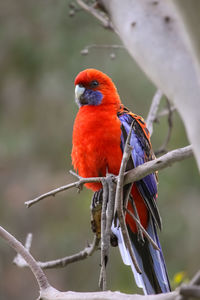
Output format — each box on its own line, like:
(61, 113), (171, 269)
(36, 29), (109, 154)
(113, 112), (170, 294)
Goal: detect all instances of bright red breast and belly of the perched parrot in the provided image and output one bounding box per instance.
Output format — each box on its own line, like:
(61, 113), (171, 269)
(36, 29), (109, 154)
(72, 105), (122, 191)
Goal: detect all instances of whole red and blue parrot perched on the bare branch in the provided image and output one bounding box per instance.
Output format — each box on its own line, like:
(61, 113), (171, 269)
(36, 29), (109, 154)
(71, 68), (171, 294)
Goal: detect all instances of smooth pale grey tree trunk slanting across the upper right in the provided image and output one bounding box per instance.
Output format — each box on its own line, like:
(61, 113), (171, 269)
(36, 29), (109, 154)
(101, 0), (200, 169)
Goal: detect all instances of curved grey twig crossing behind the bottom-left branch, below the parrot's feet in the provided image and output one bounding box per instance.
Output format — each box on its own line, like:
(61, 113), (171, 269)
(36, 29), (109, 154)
(13, 236), (100, 269)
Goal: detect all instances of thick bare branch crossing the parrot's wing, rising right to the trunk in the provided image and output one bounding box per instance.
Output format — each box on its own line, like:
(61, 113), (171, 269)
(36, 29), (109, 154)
(124, 145), (193, 185)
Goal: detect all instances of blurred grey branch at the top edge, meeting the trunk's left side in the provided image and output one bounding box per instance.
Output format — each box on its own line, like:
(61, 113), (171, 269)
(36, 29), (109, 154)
(76, 0), (114, 30)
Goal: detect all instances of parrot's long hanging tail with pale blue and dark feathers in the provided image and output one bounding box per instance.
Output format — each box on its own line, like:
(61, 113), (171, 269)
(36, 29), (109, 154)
(112, 217), (171, 295)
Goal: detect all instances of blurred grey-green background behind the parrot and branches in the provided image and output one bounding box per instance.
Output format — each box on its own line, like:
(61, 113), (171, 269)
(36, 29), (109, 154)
(0, 0), (200, 300)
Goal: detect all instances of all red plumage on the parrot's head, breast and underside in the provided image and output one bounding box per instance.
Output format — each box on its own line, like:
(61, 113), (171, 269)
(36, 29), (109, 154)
(72, 69), (148, 232)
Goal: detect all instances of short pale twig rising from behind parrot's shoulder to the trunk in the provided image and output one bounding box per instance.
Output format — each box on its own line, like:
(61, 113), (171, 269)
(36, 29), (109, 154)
(146, 89), (163, 135)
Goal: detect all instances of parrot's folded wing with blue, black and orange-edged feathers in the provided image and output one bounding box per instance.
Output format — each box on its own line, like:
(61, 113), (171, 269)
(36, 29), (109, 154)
(118, 106), (162, 229)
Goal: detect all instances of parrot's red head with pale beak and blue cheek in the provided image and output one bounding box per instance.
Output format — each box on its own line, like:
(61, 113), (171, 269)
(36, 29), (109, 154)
(75, 69), (120, 106)
